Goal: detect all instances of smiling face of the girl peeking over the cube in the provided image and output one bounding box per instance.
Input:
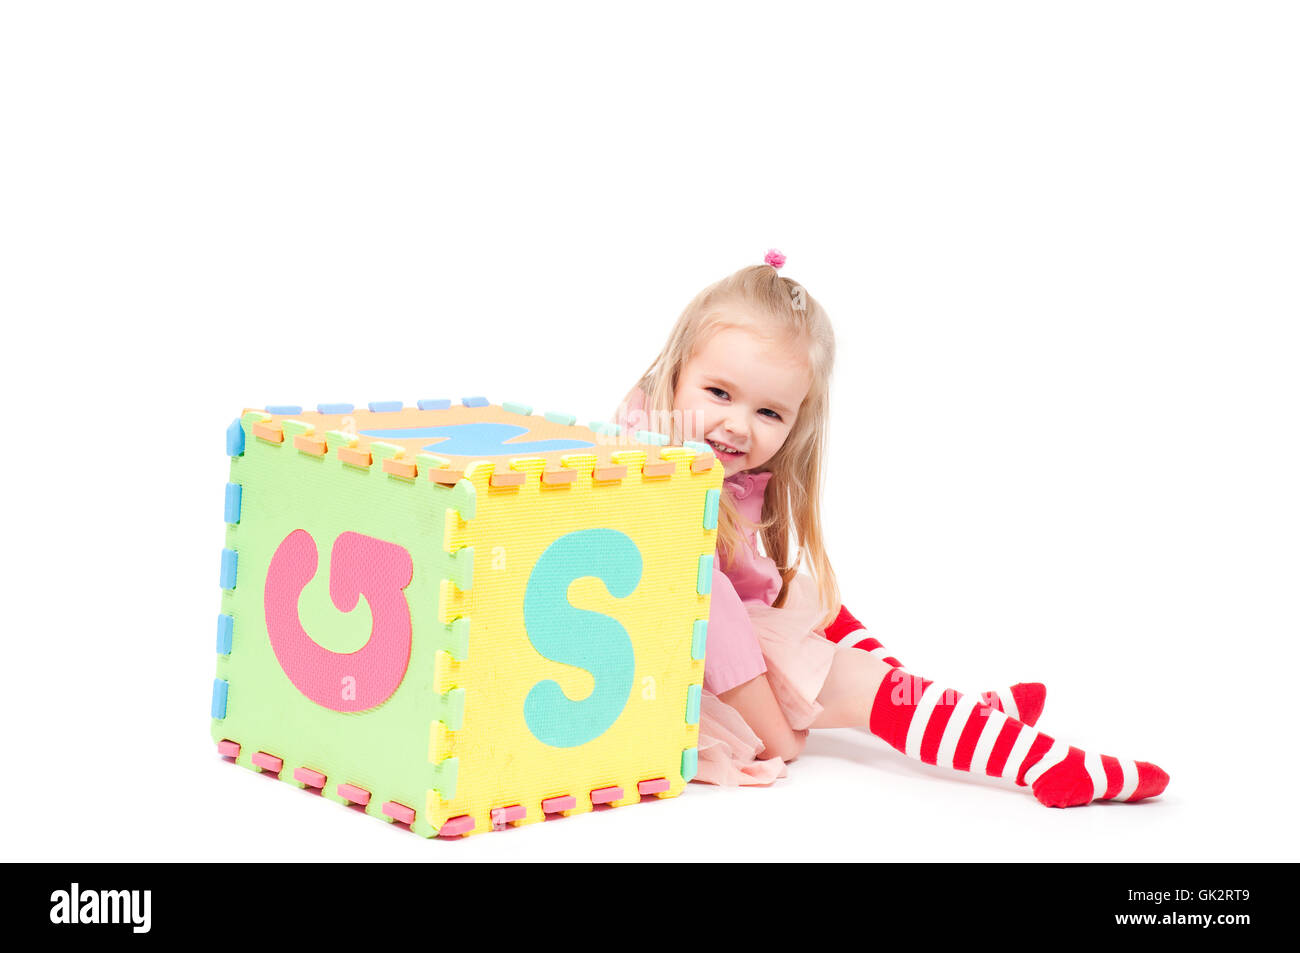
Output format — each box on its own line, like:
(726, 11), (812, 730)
(673, 315), (811, 476)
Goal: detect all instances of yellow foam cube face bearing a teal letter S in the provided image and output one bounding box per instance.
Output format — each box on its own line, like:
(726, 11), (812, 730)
(430, 449), (722, 826)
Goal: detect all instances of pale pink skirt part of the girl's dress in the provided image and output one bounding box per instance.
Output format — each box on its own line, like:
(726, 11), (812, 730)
(696, 573), (835, 785)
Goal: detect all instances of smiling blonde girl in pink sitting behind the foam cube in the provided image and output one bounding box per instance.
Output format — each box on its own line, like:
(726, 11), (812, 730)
(615, 251), (1169, 807)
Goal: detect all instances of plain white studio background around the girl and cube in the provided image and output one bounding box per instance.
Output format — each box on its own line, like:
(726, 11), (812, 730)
(0, 3), (1300, 862)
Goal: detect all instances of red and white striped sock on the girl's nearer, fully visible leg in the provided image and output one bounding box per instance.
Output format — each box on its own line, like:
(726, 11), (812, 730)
(870, 668), (1169, 807)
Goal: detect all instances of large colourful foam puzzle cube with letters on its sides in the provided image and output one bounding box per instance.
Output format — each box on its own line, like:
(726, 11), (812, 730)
(212, 398), (723, 836)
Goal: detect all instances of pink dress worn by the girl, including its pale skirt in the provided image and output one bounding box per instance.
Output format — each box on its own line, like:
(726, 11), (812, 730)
(616, 389), (835, 785)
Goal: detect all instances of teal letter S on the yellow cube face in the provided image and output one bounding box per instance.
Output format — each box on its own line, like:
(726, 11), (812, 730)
(524, 529), (641, 748)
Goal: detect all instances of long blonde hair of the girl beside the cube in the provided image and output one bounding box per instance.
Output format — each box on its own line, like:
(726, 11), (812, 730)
(619, 265), (840, 627)
